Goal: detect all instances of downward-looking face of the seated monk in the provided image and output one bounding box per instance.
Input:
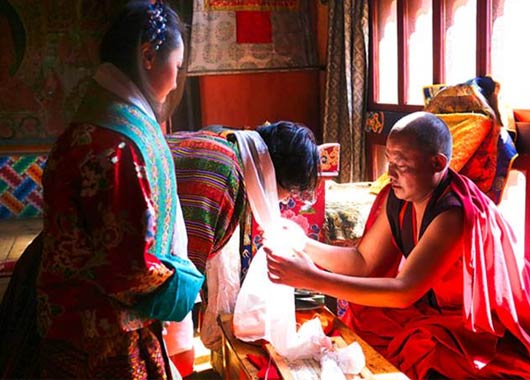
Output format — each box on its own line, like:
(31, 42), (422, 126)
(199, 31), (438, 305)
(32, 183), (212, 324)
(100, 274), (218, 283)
(385, 134), (436, 203)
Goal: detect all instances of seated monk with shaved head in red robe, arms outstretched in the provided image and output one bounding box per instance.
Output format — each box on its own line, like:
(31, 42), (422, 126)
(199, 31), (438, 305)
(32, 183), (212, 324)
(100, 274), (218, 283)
(266, 112), (530, 379)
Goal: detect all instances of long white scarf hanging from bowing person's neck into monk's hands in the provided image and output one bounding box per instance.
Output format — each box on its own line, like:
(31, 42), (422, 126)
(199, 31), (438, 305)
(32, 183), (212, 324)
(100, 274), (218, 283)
(233, 131), (296, 355)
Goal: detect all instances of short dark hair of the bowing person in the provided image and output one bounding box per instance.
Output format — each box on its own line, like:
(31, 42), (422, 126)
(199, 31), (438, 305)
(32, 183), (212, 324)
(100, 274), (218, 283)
(256, 121), (320, 192)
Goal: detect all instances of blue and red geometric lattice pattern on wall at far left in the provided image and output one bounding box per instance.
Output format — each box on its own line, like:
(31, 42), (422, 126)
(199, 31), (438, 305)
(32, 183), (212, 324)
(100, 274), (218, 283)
(0, 155), (46, 219)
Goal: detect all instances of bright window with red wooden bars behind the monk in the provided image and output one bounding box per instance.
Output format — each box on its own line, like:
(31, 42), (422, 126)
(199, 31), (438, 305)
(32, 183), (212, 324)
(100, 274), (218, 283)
(369, 0), (530, 111)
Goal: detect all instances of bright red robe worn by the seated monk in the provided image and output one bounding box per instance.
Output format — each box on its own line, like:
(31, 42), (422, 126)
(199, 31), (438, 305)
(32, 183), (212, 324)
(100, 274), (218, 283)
(342, 172), (530, 379)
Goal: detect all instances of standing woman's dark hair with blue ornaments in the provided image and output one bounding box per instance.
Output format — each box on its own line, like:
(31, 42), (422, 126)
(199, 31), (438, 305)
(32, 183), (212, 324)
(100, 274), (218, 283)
(99, 0), (185, 117)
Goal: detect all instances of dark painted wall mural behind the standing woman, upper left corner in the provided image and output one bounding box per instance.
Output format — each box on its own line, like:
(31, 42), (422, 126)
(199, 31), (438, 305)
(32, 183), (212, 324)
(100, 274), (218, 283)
(0, 0), (123, 151)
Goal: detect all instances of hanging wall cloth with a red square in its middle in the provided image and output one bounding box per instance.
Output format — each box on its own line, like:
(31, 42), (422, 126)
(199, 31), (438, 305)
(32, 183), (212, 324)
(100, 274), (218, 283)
(188, 0), (317, 75)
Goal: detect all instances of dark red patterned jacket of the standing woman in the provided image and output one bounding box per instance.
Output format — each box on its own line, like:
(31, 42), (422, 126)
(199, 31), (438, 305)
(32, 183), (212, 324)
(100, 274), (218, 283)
(37, 125), (172, 341)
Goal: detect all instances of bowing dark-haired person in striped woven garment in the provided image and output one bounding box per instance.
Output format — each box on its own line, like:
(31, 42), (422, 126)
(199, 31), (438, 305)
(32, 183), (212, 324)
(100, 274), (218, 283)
(165, 121), (320, 373)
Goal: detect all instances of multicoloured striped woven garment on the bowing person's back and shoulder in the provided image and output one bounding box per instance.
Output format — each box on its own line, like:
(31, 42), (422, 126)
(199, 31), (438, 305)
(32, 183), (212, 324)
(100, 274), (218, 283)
(166, 131), (247, 272)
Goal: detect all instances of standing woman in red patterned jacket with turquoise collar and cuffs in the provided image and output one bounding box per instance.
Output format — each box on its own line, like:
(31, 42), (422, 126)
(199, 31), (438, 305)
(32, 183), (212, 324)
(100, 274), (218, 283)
(0, 1), (204, 379)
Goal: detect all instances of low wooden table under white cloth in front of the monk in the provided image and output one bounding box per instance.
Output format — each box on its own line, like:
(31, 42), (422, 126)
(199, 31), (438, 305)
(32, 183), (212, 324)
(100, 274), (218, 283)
(219, 307), (407, 380)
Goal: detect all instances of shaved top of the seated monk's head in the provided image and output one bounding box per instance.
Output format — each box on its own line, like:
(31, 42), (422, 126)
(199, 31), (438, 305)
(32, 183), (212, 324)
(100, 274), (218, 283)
(389, 112), (453, 160)
